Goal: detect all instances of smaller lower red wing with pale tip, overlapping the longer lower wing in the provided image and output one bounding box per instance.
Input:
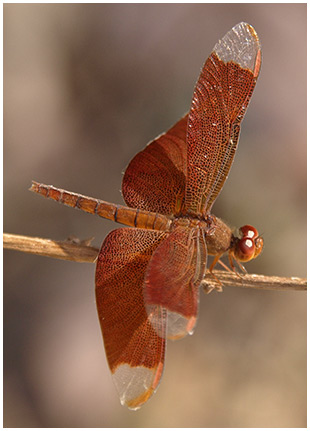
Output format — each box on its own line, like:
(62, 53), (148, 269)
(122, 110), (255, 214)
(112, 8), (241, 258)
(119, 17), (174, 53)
(144, 227), (207, 339)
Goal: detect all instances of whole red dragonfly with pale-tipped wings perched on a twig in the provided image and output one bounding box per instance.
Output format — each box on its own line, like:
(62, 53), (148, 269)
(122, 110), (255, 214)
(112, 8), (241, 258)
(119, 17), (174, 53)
(31, 23), (263, 409)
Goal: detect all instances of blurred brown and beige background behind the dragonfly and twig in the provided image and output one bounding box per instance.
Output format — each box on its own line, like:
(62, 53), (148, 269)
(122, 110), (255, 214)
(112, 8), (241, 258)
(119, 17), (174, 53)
(4, 4), (306, 427)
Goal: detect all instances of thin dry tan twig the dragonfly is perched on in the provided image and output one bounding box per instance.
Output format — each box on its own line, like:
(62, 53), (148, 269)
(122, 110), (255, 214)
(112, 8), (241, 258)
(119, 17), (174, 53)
(3, 233), (307, 291)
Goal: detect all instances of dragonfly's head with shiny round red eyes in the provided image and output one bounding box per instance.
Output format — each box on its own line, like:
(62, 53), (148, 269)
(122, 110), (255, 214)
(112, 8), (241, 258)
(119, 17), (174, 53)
(231, 225), (264, 262)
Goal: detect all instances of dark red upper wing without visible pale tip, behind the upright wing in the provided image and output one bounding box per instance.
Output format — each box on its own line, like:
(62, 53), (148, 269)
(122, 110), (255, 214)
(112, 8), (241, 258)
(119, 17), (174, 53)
(122, 115), (188, 215)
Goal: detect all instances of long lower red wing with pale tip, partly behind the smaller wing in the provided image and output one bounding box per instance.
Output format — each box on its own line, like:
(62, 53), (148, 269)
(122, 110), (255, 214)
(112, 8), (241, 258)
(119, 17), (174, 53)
(96, 228), (166, 409)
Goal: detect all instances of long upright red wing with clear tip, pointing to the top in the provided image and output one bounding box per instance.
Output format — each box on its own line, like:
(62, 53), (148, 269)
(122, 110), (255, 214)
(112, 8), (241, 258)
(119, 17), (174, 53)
(185, 23), (261, 214)
